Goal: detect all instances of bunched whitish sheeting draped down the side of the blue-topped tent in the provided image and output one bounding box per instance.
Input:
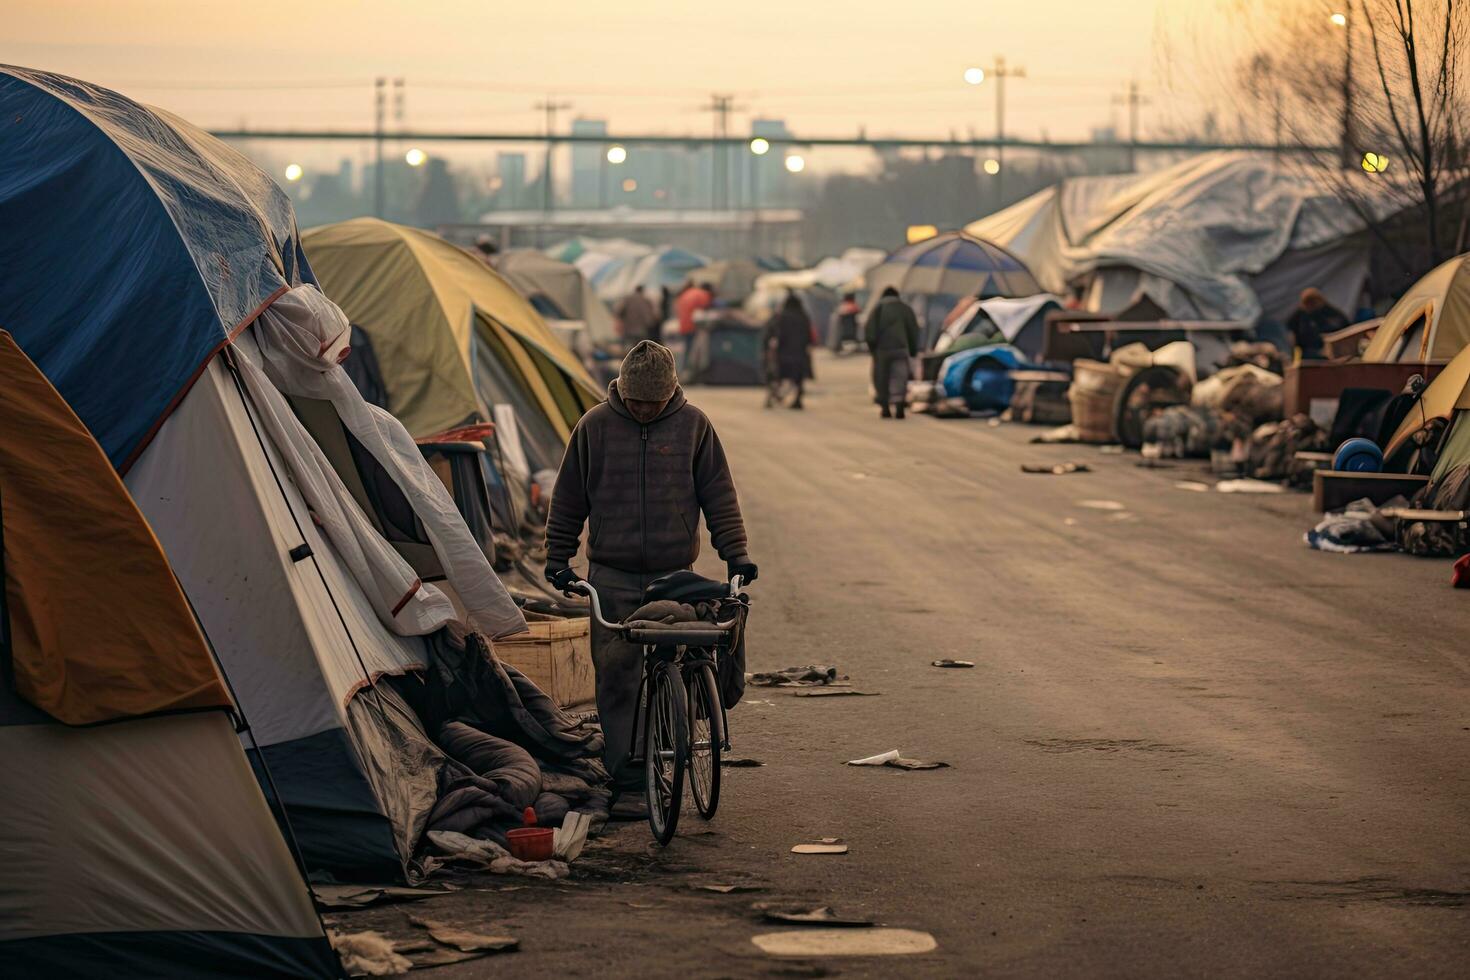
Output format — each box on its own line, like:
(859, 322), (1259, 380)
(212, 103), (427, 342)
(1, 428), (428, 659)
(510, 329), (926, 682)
(252, 285), (526, 639)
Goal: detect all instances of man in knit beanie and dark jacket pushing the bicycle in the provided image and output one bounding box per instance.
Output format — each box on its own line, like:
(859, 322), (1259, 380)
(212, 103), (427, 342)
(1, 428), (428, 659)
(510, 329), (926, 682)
(545, 341), (757, 789)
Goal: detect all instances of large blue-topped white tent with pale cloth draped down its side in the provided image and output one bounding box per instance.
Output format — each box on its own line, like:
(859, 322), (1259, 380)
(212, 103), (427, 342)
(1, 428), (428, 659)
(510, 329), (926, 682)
(0, 69), (602, 880)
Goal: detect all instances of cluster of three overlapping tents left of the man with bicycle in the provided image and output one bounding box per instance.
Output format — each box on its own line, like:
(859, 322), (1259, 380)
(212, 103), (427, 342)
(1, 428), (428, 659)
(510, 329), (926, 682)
(0, 68), (601, 977)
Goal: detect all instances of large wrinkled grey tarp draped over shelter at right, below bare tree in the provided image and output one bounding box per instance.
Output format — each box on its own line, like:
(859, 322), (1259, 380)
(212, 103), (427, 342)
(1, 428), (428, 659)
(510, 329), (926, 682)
(966, 153), (1394, 322)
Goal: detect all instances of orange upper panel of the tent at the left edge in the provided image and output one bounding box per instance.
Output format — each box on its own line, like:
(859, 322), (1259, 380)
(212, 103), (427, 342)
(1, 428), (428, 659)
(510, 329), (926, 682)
(0, 331), (231, 724)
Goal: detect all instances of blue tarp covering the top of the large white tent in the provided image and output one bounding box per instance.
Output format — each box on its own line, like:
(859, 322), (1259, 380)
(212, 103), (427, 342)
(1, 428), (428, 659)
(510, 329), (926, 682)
(0, 66), (313, 469)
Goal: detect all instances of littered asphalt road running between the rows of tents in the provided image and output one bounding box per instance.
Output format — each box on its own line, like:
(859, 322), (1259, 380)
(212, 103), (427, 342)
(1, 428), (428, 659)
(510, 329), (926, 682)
(375, 352), (1470, 977)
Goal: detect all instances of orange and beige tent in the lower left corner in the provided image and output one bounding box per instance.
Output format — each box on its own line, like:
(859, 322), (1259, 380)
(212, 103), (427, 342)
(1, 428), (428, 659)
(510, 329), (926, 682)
(0, 333), (341, 977)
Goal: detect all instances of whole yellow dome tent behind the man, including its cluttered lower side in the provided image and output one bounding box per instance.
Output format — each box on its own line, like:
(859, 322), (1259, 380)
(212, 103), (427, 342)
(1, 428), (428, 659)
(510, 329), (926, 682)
(301, 217), (601, 613)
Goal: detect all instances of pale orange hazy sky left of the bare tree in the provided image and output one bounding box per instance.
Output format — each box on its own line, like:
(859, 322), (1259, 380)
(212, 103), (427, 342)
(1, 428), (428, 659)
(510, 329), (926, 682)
(0, 0), (1193, 138)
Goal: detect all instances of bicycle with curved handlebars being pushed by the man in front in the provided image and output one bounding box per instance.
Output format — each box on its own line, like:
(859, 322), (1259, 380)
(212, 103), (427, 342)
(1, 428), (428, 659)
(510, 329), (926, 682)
(572, 574), (750, 846)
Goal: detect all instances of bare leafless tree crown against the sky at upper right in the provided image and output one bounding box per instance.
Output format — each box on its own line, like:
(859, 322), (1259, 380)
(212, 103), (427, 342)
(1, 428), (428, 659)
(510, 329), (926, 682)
(1166, 0), (1470, 273)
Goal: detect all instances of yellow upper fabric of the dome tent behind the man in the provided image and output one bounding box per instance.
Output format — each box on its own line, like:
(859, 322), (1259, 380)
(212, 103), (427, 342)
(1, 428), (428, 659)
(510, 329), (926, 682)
(301, 217), (603, 442)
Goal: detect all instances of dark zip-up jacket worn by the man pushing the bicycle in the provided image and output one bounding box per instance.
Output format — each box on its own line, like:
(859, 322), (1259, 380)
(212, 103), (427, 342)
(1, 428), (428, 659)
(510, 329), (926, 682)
(547, 381), (750, 572)
